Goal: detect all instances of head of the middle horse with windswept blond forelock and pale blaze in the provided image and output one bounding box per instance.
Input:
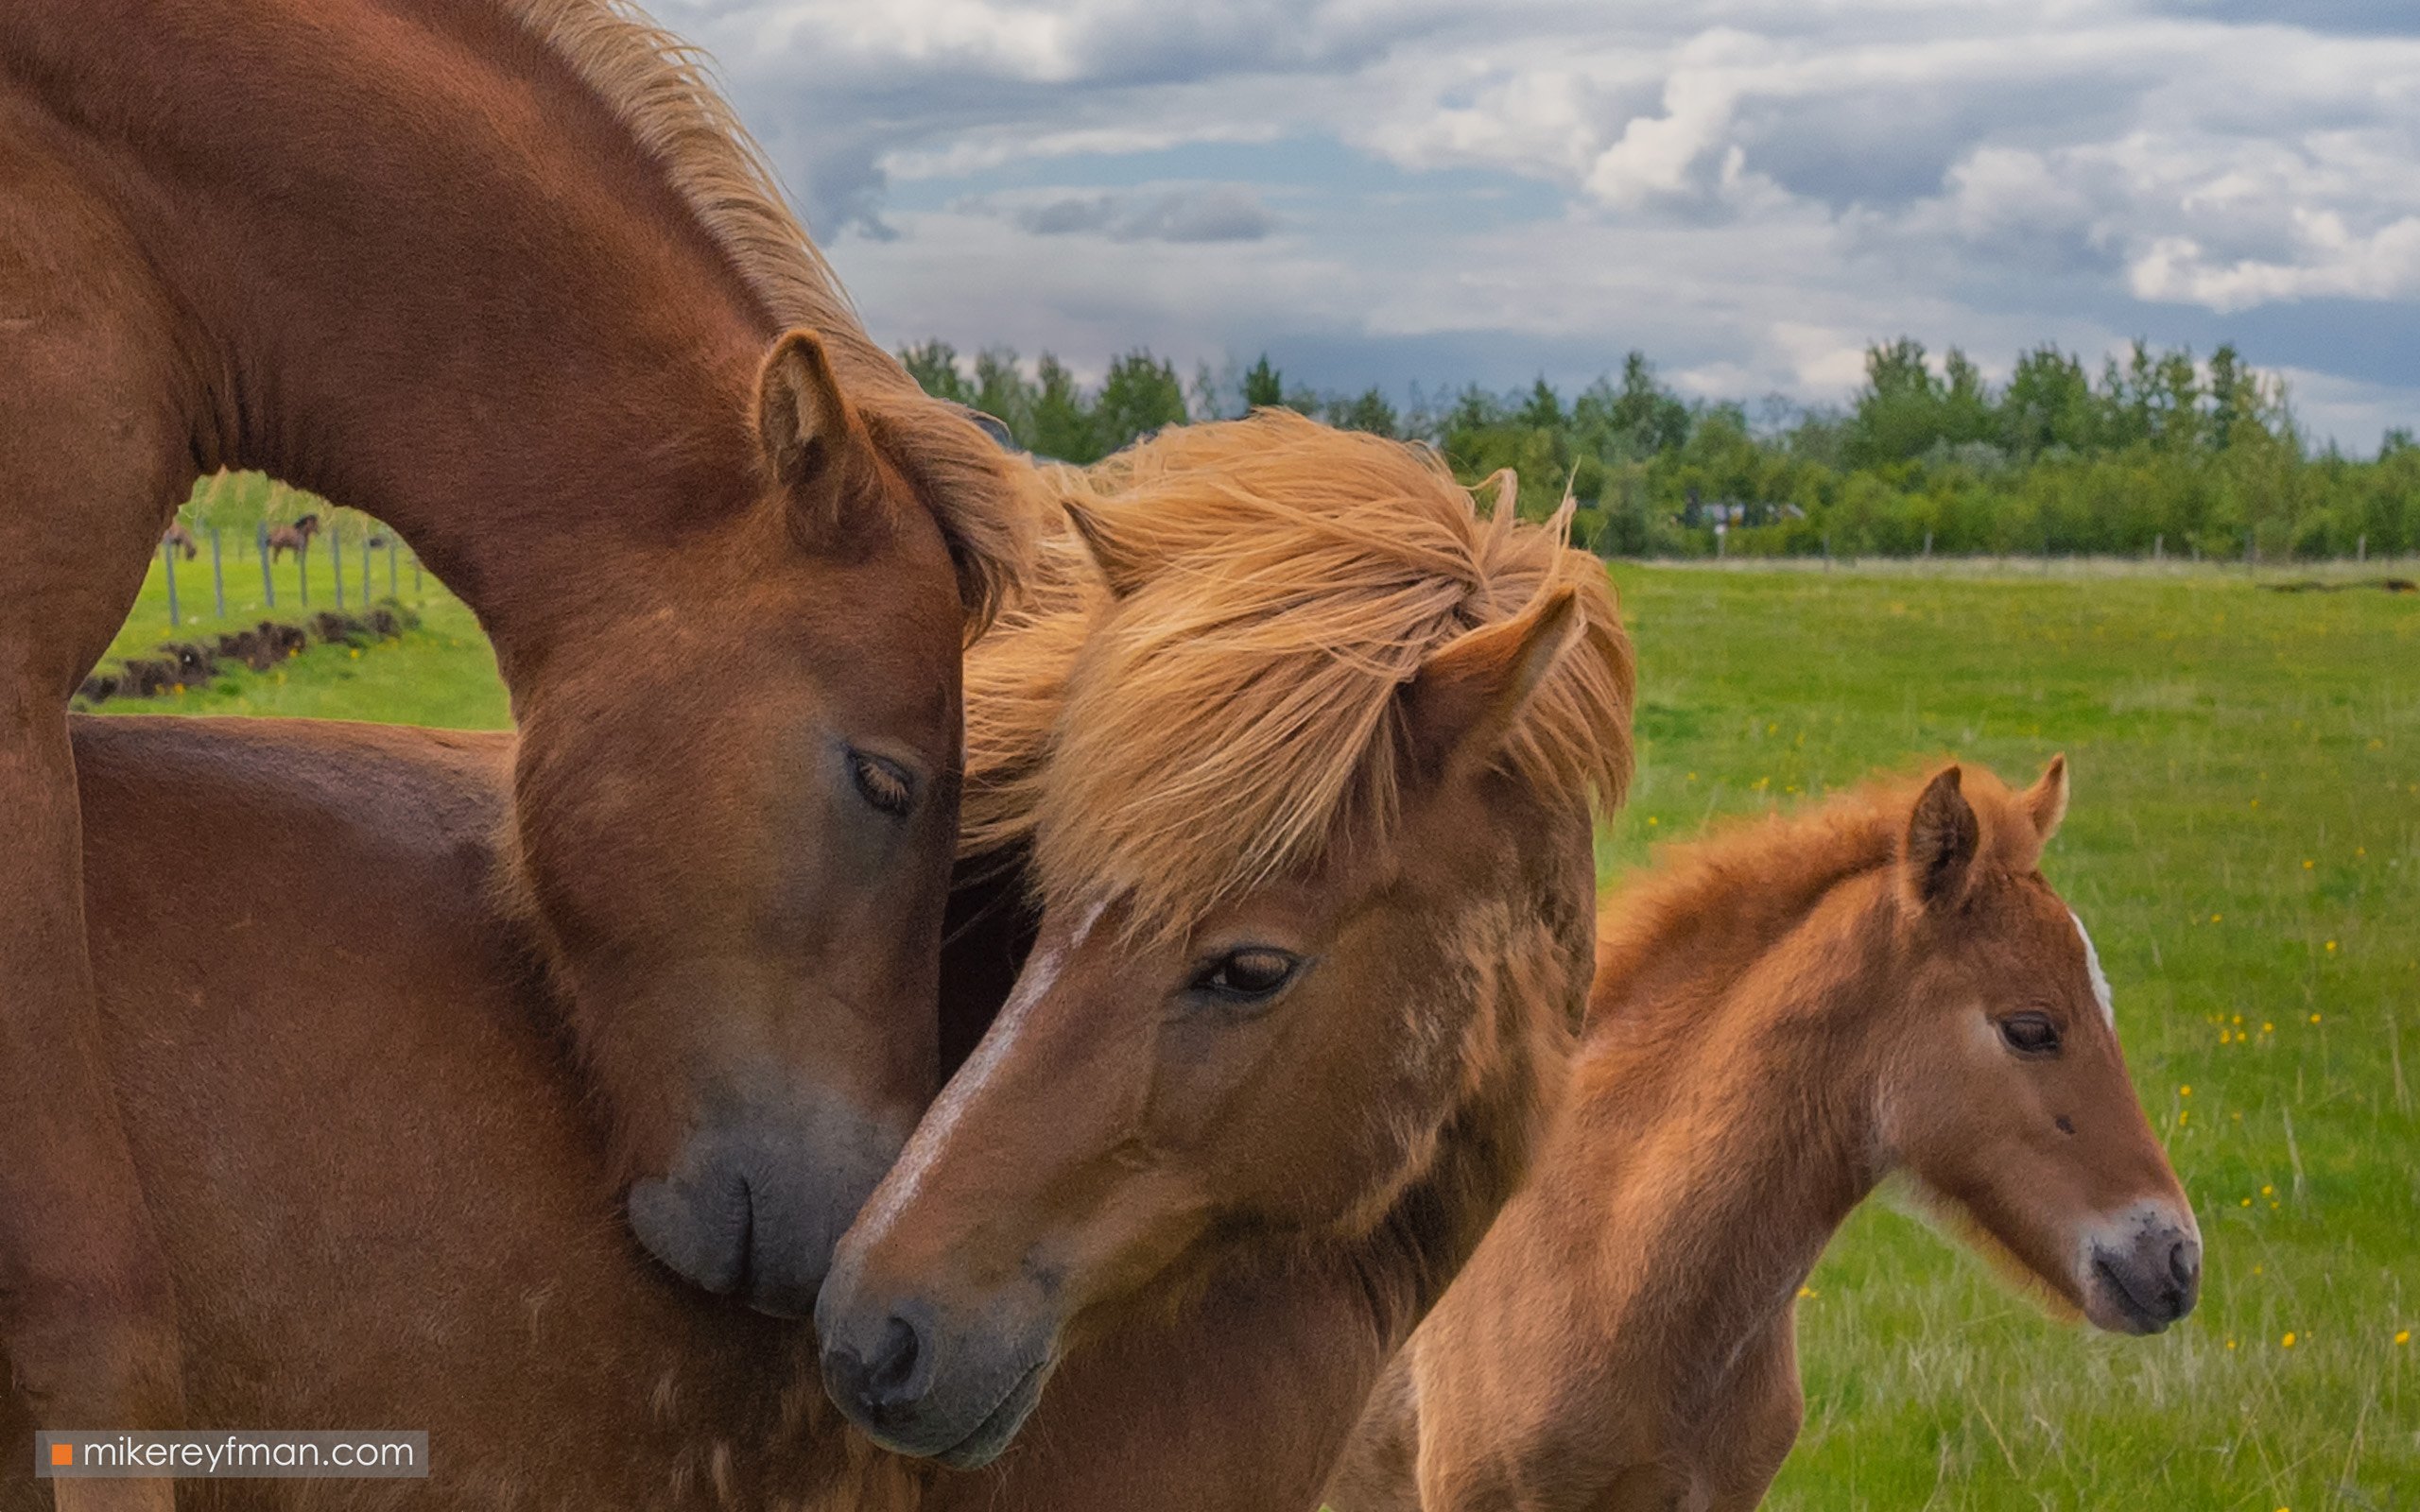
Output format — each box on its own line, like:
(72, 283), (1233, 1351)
(816, 411), (1631, 1507)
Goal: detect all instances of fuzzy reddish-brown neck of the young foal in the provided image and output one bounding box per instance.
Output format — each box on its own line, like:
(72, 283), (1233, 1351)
(1567, 873), (1894, 1400)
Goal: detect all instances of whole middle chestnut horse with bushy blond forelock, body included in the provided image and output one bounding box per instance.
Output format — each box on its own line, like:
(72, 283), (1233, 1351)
(0, 416), (1631, 1512)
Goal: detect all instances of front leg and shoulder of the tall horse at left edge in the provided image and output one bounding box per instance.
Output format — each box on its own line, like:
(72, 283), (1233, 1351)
(0, 114), (196, 1509)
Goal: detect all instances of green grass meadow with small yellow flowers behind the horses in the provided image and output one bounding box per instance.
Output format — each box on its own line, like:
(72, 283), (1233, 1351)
(112, 551), (2420, 1512)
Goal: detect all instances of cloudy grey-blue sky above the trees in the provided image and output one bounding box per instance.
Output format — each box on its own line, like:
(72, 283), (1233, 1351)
(653, 0), (2420, 450)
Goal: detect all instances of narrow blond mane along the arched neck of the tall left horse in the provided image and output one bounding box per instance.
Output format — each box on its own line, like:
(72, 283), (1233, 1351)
(498, 0), (1041, 634)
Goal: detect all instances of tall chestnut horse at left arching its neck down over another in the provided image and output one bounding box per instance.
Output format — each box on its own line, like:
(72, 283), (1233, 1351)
(0, 0), (1026, 1461)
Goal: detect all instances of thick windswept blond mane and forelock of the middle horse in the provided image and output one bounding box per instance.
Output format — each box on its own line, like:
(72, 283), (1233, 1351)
(960, 411), (1631, 926)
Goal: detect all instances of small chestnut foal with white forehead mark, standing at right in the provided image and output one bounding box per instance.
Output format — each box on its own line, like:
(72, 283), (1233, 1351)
(1328, 760), (2203, 1512)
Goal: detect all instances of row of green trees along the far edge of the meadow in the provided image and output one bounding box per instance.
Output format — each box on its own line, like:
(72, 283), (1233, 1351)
(900, 336), (2420, 561)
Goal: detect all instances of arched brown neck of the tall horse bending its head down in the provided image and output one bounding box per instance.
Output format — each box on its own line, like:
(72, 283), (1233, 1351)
(19, 0), (793, 678)
